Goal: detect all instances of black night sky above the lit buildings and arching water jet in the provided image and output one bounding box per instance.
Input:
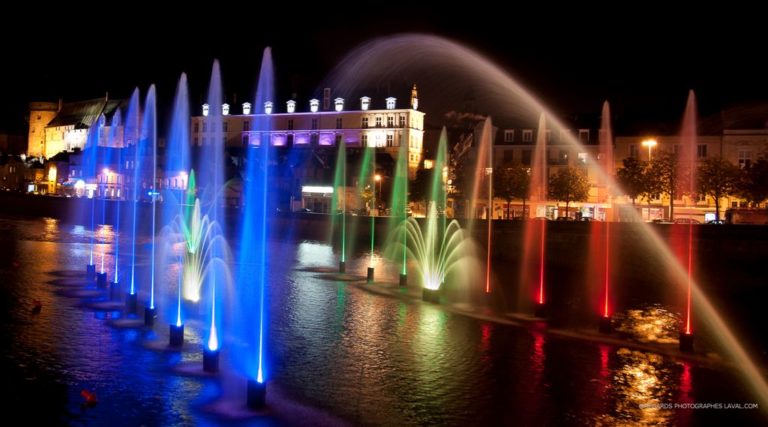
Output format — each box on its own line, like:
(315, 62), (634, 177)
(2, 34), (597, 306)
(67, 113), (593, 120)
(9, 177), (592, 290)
(0, 8), (768, 133)
